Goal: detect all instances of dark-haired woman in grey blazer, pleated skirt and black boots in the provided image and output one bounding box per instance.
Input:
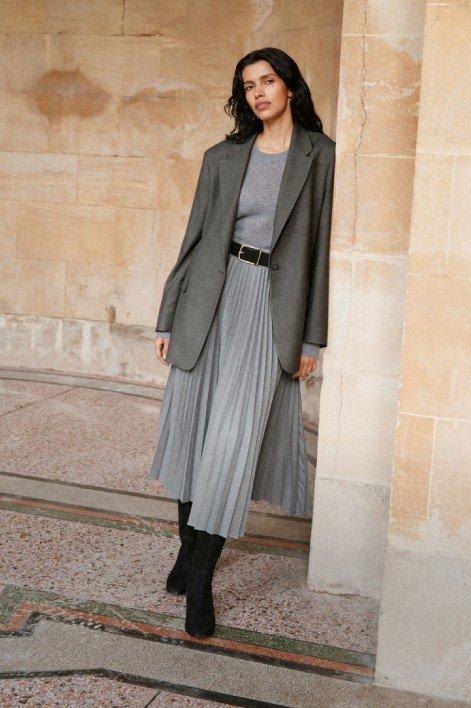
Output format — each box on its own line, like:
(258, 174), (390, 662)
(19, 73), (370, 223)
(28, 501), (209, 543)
(150, 47), (335, 637)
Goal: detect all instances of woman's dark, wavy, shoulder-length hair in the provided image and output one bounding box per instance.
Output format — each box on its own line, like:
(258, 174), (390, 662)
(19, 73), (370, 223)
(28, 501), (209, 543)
(224, 47), (323, 143)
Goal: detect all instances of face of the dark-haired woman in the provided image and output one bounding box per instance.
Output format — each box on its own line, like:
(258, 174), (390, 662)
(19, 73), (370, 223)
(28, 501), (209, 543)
(242, 59), (293, 121)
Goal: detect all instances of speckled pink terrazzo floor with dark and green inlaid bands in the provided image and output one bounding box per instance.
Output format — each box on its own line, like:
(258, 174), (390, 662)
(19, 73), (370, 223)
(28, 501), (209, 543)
(0, 369), (460, 708)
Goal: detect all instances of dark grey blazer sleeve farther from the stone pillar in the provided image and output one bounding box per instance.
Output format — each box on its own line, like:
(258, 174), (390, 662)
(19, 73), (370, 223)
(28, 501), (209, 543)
(155, 151), (210, 332)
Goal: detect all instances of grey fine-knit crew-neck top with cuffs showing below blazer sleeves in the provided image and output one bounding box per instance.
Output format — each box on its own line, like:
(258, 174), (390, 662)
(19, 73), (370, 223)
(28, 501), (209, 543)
(157, 143), (319, 357)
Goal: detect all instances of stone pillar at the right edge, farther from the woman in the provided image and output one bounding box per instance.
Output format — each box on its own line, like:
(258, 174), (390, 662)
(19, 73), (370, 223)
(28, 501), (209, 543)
(376, 0), (471, 700)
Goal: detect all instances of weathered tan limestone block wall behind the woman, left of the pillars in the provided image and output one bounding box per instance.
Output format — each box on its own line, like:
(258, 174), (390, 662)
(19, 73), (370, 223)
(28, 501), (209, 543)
(0, 0), (342, 392)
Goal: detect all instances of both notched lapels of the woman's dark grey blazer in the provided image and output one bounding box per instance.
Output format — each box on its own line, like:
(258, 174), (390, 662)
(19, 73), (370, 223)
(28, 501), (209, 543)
(219, 123), (313, 257)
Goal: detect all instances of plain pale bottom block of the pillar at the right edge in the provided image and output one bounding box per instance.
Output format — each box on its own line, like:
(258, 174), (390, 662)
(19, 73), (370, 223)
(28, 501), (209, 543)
(375, 546), (471, 706)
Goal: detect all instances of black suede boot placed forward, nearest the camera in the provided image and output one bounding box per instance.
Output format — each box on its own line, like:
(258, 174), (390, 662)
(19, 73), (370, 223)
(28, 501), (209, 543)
(185, 530), (226, 637)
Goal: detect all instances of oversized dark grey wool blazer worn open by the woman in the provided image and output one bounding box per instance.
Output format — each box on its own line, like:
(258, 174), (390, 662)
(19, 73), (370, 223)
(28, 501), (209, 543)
(155, 123), (335, 373)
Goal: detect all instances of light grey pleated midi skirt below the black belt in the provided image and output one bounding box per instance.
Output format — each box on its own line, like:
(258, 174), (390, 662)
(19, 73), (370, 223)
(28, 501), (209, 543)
(149, 249), (312, 538)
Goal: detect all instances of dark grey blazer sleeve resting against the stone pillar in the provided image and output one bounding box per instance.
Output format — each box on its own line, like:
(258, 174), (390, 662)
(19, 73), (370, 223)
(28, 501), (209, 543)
(303, 146), (335, 347)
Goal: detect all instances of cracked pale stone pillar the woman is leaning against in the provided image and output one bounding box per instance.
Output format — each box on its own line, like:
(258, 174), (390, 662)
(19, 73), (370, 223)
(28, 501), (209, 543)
(308, 0), (424, 598)
